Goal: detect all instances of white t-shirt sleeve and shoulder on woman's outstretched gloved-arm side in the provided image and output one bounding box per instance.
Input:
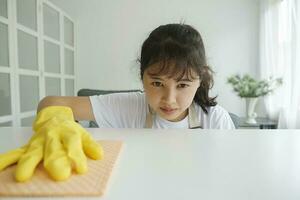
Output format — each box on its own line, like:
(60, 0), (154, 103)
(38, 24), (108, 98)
(90, 92), (146, 128)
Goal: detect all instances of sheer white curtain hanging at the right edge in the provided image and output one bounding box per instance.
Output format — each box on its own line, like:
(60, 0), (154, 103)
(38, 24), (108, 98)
(260, 0), (300, 128)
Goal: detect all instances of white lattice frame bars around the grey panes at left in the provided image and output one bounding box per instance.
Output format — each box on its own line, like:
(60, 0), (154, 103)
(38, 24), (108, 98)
(0, 0), (77, 127)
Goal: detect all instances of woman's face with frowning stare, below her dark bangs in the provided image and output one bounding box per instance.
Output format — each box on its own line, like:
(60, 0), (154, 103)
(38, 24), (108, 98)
(143, 64), (200, 122)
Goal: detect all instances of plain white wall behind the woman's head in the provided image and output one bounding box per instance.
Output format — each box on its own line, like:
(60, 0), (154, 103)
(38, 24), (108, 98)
(51, 0), (259, 115)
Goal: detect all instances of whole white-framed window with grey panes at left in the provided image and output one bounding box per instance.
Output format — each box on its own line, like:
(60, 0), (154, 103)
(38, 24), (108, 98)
(0, 0), (76, 126)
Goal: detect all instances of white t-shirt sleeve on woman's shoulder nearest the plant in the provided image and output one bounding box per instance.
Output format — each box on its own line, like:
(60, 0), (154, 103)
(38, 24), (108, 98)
(209, 105), (235, 129)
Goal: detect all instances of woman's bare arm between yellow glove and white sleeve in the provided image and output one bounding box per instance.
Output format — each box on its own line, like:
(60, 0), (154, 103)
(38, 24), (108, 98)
(37, 96), (95, 121)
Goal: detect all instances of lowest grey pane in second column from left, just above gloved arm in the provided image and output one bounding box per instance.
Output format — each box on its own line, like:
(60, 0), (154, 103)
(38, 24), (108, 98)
(19, 75), (39, 112)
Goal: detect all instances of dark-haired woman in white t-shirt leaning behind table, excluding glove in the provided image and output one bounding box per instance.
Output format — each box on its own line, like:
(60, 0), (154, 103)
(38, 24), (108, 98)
(38, 24), (234, 129)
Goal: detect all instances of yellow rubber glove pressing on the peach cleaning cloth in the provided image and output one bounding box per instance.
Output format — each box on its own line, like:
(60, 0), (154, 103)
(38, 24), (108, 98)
(0, 106), (103, 182)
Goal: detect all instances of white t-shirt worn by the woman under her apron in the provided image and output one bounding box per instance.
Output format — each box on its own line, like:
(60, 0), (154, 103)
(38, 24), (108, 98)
(90, 92), (234, 129)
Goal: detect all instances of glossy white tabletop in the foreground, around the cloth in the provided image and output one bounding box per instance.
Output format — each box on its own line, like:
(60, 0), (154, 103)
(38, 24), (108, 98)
(0, 128), (300, 200)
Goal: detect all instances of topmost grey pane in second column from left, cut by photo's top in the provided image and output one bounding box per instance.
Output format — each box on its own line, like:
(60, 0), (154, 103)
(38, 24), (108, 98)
(17, 0), (37, 30)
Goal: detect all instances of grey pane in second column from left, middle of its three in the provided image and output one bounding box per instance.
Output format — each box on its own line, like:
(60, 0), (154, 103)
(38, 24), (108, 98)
(18, 31), (38, 70)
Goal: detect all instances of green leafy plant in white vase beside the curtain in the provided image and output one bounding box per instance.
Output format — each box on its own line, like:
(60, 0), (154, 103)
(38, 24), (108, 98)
(227, 74), (282, 124)
